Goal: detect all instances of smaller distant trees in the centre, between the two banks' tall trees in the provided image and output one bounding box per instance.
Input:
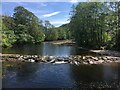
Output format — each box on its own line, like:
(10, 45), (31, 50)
(44, 21), (70, 41)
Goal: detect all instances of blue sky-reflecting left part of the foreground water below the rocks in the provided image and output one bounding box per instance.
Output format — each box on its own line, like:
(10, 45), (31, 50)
(3, 63), (73, 88)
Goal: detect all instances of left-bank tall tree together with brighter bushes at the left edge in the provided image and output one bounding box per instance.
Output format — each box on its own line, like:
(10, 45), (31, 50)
(1, 6), (45, 47)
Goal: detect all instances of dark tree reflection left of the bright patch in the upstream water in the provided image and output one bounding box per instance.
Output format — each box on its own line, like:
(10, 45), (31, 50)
(2, 44), (43, 55)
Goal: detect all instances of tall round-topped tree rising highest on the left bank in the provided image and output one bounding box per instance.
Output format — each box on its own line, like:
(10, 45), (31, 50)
(13, 6), (44, 43)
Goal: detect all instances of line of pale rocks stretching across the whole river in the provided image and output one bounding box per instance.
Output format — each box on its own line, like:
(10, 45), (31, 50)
(1, 54), (120, 65)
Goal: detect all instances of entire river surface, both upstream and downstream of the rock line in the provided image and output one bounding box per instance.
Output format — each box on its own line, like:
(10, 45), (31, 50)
(3, 43), (120, 88)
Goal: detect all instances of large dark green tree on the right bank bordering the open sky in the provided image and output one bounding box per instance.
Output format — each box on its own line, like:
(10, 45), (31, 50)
(70, 2), (111, 49)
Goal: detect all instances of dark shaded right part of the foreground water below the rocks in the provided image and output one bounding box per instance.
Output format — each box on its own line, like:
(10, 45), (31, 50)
(71, 63), (120, 88)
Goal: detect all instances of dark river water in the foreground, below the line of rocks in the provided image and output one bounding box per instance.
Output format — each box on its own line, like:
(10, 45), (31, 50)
(3, 62), (120, 88)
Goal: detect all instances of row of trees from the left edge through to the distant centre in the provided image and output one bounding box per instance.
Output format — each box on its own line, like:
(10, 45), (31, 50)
(0, 6), (70, 47)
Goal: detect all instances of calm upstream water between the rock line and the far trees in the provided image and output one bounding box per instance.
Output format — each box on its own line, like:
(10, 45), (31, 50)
(2, 43), (90, 56)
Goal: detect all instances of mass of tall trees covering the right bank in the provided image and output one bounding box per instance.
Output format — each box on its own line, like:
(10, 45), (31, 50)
(69, 2), (120, 50)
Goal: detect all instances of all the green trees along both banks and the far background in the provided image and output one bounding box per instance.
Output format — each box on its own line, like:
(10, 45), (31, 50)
(0, 2), (120, 50)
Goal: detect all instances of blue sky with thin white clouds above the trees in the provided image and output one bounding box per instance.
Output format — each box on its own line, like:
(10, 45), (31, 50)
(2, 0), (77, 27)
